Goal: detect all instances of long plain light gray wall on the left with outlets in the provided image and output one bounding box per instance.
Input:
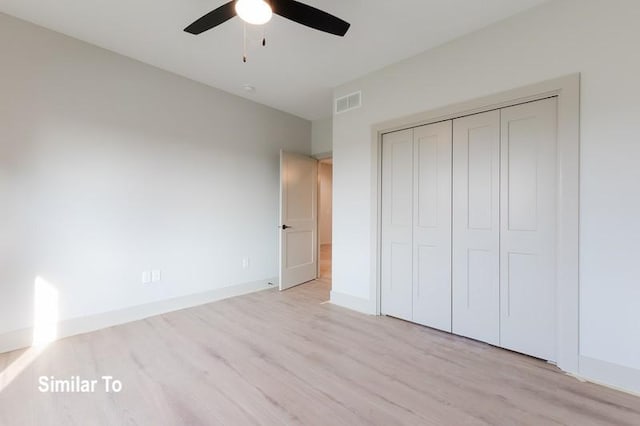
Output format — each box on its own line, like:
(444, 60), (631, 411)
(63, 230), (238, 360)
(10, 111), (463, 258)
(0, 14), (311, 334)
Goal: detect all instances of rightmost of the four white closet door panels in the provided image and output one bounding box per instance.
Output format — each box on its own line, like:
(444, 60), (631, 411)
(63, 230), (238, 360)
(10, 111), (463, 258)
(500, 98), (557, 361)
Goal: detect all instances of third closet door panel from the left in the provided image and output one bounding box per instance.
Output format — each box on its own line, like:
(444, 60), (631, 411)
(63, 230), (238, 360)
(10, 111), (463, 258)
(452, 111), (500, 345)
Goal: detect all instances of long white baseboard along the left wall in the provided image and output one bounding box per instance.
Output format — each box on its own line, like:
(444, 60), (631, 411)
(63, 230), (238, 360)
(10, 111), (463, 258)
(0, 278), (278, 353)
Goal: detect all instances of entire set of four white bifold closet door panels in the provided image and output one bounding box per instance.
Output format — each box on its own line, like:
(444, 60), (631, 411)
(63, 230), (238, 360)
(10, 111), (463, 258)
(381, 98), (558, 361)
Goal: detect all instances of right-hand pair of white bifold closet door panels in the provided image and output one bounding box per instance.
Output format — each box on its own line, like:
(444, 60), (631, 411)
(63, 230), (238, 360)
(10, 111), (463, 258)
(452, 98), (557, 361)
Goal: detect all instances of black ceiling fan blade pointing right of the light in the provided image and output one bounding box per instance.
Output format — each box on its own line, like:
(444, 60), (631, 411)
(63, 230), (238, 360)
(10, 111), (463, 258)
(269, 0), (351, 37)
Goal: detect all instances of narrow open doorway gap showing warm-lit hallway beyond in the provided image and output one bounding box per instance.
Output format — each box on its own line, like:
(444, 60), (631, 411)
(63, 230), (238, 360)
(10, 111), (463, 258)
(318, 158), (333, 283)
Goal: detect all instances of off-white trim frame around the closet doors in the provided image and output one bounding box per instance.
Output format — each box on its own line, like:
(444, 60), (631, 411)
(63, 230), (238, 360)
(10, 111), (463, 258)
(370, 73), (580, 374)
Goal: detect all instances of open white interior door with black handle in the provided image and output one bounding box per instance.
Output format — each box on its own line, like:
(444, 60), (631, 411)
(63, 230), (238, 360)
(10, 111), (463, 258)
(280, 151), (318, 290)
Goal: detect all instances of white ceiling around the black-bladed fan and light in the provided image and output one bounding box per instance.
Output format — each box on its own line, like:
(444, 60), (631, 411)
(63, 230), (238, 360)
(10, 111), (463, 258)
(0, 0), (547, 120)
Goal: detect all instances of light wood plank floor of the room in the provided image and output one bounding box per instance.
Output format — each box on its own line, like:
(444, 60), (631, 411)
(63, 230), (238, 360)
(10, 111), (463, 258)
(0, 281), (640, 426)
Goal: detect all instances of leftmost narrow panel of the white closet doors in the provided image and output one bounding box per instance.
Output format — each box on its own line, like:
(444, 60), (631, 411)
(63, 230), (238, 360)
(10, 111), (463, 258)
(381, 130), (413, 320)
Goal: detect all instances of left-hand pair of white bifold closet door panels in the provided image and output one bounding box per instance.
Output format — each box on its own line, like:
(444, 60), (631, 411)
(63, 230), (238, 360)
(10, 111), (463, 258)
(382, 121), (452, 332)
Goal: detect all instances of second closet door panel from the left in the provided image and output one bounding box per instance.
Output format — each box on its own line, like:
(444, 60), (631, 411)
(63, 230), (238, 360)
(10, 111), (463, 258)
(413, 121), (452, 332)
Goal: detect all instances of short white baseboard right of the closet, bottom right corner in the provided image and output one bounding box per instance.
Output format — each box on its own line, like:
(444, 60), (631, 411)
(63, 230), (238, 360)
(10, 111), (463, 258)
(577, 356), (640, 396)
